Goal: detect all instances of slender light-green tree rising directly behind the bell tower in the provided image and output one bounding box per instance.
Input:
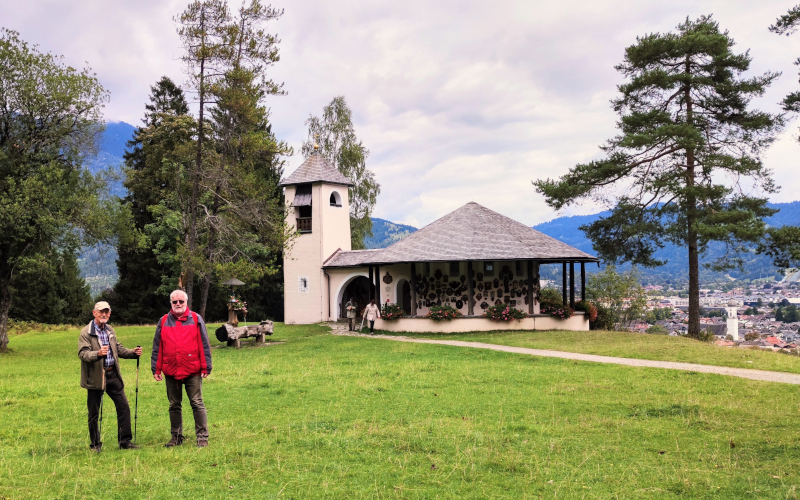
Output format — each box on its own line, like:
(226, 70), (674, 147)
(303, 96), (381, 250)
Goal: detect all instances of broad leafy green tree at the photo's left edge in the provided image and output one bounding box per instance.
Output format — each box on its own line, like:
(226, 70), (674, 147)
(0, 29), (117, 352)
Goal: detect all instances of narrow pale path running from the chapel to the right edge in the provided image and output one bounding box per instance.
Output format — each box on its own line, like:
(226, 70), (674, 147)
(328, 323), (800, 385)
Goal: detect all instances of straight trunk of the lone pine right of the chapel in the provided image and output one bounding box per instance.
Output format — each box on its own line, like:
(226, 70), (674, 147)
(684, 56), (700, 338)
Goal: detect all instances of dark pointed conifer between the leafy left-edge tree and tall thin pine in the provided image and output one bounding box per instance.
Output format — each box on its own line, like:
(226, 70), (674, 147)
(106, 76), (189, 324)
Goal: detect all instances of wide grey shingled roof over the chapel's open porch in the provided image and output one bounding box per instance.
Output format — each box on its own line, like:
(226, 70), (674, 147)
(324, 202), (597, 267)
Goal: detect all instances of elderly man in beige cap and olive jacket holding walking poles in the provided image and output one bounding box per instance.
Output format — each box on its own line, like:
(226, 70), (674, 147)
(78, 301), (142, 453)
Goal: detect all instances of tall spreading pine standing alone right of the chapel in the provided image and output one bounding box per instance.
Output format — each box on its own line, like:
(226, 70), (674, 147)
(534, 17), (783, 337)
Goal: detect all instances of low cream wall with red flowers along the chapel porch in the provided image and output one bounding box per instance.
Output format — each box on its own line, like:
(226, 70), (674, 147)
(375, 312), (589, 333)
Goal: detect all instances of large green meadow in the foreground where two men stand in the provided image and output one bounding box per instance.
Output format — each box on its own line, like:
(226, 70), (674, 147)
(0, 325), (800, 499)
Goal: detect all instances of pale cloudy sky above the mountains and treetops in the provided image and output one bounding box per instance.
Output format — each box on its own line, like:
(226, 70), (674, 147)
(6, 0), (800, 227)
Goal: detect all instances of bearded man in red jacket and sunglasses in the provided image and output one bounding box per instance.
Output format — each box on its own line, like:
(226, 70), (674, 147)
(150, 290), (211, 448)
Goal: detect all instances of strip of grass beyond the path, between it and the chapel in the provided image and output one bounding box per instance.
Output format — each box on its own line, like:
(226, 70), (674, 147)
(379, 330), (800, 373)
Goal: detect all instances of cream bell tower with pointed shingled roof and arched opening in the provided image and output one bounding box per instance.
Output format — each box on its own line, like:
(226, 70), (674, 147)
(280, 144), (353, 324)
